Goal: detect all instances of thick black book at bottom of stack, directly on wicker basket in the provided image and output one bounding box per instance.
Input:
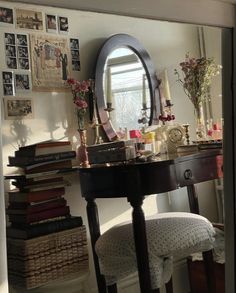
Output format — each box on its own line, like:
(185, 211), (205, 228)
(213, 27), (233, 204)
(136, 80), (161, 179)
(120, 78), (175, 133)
(6, 217), (83, 239)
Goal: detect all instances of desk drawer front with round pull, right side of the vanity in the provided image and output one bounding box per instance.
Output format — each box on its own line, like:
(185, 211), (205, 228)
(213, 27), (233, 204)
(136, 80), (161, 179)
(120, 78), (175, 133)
(176, 155), (223, 187)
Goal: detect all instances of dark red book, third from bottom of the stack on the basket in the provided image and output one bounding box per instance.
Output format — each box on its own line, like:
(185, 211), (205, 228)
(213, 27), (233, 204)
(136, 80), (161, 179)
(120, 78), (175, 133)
(6, 198), (66, 215)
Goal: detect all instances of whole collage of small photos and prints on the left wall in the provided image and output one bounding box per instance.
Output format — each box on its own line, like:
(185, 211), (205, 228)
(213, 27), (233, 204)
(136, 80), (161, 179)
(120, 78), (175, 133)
(0, 7), (81, 119)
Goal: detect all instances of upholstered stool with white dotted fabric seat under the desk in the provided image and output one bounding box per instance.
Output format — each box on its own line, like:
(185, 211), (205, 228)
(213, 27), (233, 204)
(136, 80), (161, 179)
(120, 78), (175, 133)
(95, 212), (215, 292)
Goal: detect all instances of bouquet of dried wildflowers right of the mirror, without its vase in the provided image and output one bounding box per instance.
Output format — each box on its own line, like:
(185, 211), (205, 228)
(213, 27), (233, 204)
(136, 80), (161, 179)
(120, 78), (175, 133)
(174, 54), (221, 111)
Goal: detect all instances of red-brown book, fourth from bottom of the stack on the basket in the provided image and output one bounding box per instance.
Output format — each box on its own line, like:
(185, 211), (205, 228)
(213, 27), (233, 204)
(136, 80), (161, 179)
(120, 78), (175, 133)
(8, 187), (65, 203)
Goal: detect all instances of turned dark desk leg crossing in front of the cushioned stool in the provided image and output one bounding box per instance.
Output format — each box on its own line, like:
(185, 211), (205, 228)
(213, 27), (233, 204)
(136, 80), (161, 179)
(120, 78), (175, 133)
(130, 198), (151, 293)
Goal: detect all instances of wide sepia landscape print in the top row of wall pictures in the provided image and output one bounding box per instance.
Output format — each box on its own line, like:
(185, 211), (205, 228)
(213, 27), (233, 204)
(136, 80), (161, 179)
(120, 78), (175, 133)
(16, 9), (43, 31)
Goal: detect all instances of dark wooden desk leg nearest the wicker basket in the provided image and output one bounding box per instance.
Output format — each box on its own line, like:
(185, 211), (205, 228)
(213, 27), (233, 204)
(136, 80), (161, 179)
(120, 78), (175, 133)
(86, 198), (106, 293)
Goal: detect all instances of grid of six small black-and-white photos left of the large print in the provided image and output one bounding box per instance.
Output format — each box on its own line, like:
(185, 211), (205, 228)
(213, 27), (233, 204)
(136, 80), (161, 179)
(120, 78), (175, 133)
(5, 33), (30, 70)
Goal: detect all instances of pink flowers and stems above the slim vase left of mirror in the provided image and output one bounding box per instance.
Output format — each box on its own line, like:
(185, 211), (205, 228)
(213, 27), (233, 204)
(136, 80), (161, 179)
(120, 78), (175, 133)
(67, 78), (91, 130)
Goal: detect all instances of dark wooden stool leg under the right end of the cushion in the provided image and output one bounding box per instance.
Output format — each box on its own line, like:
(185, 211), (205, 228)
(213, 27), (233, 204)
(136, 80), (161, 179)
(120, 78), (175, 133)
(202, 250), (216, 293)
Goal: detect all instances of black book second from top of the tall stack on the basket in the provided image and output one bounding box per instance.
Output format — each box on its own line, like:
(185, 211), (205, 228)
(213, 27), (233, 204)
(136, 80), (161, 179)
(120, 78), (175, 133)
(8, 151), (76, 167)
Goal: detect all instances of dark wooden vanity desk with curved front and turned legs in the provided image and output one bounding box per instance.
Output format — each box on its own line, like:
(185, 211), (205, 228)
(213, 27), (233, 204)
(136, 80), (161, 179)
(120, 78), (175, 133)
(79, 149), (223, 293)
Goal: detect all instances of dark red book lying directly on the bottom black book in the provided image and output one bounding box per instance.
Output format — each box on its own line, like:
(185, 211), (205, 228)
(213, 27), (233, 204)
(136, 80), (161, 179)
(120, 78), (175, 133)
(8, 206), (70, 224)
